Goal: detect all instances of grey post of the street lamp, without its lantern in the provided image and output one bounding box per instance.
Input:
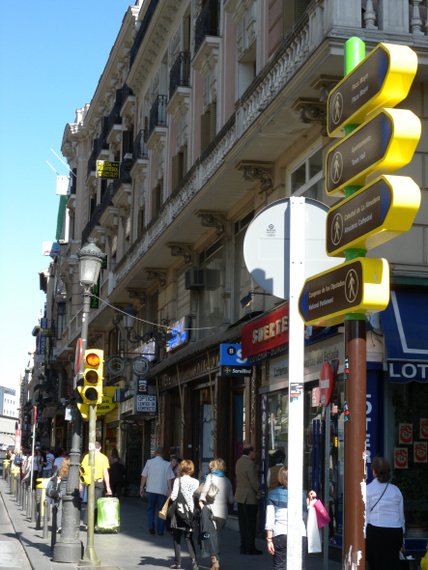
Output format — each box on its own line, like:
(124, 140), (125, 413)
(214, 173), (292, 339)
(53, 287), (91, 562)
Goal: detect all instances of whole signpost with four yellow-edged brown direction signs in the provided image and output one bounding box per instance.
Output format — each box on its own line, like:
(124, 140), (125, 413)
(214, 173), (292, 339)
(299, 38), (421, 569)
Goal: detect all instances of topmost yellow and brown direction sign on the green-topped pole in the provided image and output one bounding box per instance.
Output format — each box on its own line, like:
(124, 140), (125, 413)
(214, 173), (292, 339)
(327, 43), (418, 137)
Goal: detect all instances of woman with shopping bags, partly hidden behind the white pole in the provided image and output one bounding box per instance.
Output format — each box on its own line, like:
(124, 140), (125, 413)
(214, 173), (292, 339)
(265, 466), (317, 570)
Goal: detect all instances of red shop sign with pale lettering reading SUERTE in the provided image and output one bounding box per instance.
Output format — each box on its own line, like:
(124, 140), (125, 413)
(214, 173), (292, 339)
(241, 305), (289, 357)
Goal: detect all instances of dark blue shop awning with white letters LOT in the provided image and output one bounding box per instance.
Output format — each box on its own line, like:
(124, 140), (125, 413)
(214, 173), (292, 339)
(380, 291), (428, 382)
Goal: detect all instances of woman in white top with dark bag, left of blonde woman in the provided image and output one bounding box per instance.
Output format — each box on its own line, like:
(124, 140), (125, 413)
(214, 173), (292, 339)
(170, 459), (199, 570)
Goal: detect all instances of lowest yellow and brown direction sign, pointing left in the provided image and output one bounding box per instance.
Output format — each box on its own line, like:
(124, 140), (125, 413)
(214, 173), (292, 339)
(299, 257), (389, 327)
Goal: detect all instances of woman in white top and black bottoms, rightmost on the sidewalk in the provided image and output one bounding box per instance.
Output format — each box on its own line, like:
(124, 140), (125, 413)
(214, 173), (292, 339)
(366, 457), (406, 570)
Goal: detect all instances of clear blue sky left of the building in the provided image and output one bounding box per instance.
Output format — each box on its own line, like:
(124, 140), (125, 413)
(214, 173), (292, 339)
(0, 0), (134, 388)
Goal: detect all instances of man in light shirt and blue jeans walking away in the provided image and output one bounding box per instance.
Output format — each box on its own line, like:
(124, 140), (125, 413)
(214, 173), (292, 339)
(140, 446), (174, 535)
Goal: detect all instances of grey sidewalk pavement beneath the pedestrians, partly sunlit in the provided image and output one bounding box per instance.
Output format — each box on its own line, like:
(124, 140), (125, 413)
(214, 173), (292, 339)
(0, 479), (341, 570)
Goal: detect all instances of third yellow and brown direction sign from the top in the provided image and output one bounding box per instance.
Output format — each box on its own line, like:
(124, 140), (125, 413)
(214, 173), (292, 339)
(326, 176), (421, 256)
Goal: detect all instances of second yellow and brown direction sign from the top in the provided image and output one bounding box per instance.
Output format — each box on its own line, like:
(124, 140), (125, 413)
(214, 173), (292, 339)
(325, 109), (421, 196)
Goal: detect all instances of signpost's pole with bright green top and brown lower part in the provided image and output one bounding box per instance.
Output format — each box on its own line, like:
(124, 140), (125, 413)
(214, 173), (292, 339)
(342, 38), (367, 570)
